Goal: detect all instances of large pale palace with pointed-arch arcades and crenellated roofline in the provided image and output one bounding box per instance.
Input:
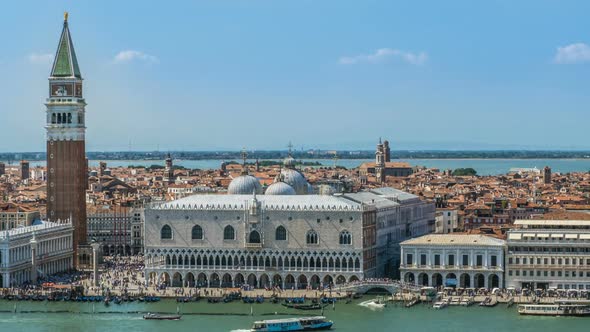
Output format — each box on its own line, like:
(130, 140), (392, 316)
(145, 187), (434, 288)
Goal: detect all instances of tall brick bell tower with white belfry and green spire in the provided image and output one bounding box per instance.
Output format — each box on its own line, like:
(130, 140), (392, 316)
(45, 13), (87, 267)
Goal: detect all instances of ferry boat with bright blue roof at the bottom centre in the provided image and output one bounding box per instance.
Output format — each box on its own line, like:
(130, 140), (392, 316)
(250, 316), (334, 332)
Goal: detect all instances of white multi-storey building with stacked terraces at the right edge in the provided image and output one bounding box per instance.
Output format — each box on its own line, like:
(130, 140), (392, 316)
(506, 220), (590, 290)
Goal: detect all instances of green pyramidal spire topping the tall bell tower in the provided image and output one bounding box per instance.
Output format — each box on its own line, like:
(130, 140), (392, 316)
(51, 12), (82, 79)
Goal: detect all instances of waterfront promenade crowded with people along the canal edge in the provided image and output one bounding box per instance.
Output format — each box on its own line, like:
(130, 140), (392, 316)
(1, 256), (589, 303)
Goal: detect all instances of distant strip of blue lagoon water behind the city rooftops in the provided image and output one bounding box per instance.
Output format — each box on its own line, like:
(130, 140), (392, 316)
(8, 158), (590, 175)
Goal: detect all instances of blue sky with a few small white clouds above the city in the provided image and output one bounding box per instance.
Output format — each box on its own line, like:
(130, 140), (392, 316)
(0, 0), (590, 151)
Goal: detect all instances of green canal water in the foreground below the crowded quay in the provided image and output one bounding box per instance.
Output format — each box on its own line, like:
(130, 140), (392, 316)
(0, 298), (590, 332)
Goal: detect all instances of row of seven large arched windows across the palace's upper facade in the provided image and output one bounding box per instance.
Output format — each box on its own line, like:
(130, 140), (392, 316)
(160, 225), (352, 245)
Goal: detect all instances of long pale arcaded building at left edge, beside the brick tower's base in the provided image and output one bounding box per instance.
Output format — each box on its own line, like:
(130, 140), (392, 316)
(0, 221), (74, 288)
